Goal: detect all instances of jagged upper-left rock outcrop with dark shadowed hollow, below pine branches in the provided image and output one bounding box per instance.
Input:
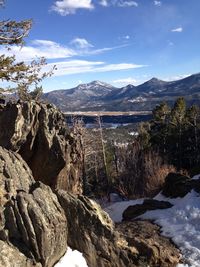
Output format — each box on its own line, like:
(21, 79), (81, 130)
(0, 101), (82, 194)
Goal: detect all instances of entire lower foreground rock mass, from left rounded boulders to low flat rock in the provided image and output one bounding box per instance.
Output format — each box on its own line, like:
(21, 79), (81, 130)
(0, 147), (181, 267)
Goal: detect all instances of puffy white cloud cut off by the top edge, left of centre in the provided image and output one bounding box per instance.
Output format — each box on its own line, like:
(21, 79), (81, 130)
(51, 0), (94, 16)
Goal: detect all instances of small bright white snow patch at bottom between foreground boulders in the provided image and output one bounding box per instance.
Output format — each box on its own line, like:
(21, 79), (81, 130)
(54, 247), (88, 267)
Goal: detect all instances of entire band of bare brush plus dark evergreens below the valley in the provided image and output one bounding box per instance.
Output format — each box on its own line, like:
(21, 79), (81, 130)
(75, 97), (200, 198)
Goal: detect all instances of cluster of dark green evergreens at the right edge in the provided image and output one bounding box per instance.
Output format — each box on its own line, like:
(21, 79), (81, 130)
(139, 97), (200, 174)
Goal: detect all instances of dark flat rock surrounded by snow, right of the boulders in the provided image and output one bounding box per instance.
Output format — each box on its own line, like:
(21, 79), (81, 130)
(122, 199), (173, 220)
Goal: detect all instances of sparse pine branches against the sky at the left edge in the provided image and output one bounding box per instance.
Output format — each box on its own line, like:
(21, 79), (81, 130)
(0, 0), (55, 100)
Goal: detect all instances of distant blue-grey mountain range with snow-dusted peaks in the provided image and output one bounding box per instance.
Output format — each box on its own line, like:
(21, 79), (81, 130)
(43, 73), (200, 112)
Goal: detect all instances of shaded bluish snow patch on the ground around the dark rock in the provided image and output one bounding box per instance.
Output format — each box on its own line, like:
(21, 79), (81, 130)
(106, 187), (200, 267)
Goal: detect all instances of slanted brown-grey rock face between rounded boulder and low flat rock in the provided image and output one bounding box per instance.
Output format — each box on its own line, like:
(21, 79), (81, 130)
(56, 190), (140, 267)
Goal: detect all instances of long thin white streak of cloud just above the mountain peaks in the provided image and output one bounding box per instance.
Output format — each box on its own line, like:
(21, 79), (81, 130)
(45, 60), (145, 76)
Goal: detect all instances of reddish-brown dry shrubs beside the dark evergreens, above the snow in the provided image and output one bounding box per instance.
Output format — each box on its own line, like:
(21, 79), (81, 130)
(115, 144), (176, 198)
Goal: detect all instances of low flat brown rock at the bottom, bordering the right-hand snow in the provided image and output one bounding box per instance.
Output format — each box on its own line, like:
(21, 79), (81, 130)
(116, 221), (181, 267)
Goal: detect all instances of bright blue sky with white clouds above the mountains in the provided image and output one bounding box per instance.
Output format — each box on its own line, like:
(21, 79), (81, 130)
(0, 0), (200, 92)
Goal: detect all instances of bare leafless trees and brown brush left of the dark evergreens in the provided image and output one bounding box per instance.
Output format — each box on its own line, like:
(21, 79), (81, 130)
(73, 118), (175, 199)
